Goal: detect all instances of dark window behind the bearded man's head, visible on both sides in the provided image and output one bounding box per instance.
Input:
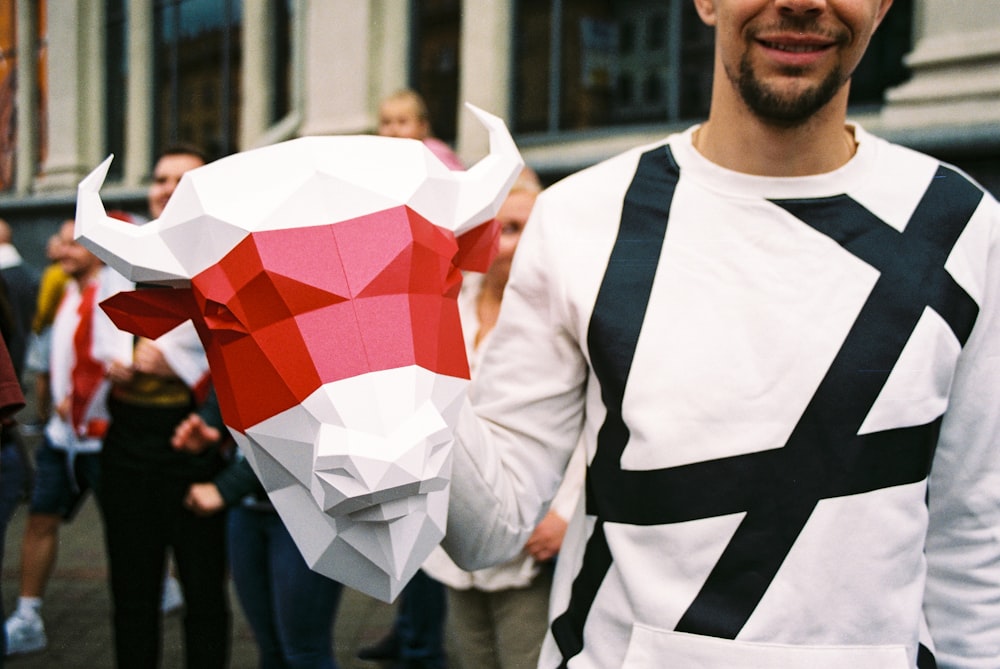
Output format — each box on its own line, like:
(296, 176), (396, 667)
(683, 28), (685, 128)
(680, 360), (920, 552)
(512, 0), (914, 133)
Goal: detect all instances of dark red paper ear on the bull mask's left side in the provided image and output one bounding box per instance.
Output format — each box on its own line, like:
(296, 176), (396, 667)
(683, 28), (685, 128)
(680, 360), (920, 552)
(101, 288), (198, 339)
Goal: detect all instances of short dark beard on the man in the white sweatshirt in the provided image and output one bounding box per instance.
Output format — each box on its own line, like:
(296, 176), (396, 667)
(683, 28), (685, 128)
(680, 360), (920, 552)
(727, 55), (848, 127)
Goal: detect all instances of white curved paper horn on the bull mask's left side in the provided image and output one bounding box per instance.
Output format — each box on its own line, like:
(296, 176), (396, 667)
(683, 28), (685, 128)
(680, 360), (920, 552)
(75, 156), (190, 286)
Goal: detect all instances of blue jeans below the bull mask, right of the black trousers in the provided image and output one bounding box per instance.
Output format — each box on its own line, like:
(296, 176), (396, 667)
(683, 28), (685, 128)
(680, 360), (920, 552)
(229, 506), (343, 669)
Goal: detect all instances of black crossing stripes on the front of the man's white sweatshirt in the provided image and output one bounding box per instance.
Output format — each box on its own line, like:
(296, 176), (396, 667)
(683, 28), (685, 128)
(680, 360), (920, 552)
(552, 148), (982, 666)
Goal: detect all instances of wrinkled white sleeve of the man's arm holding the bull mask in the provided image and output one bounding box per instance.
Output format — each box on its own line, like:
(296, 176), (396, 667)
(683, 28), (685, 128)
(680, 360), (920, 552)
(442, 195), (587, 569)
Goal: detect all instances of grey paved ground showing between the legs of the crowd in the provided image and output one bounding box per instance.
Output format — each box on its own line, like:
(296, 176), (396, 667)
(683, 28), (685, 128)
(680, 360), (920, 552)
(2, 488), (395, 669)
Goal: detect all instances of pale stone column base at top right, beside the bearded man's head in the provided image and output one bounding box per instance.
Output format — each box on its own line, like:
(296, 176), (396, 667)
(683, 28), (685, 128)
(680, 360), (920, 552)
(882, 0), (1000, 128)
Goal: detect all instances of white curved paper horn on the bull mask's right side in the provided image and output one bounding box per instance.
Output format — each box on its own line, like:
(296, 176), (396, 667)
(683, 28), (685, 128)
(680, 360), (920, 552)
(451, 103), (524, 236)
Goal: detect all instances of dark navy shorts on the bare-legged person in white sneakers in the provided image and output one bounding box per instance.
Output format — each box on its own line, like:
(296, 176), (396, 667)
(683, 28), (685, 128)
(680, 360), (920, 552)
(29, 439), (101, 520)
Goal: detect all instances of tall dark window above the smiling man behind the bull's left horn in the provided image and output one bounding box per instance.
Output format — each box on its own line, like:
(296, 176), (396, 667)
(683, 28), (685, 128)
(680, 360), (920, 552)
(155, 0), (242, 158)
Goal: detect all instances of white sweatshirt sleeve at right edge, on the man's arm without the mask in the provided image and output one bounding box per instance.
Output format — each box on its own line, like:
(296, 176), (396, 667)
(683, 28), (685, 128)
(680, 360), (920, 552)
(924, 192), (1000, 669)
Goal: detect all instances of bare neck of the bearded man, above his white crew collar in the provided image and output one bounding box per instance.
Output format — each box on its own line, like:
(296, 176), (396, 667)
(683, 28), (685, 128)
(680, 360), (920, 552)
(694, 90), (857, 177)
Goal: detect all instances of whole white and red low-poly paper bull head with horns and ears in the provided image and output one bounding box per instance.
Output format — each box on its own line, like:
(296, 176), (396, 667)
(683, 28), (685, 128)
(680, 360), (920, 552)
(76, 107), (522, 601)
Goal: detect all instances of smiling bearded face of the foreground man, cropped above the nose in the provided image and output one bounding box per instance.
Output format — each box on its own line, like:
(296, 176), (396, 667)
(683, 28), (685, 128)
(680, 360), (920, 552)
(695, 0), (892, 126)
